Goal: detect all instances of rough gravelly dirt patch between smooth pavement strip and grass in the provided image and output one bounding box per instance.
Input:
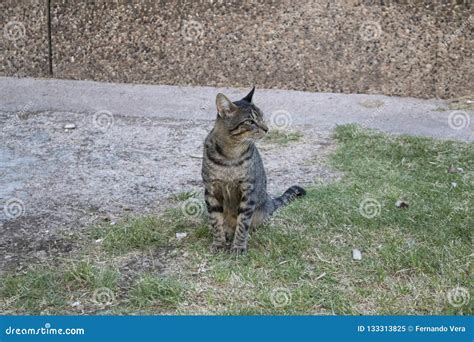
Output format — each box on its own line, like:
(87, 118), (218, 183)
(0, 111), (336, 272)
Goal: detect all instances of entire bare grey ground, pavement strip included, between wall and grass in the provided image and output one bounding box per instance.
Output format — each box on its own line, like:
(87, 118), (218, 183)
(0, 77), (474, 273)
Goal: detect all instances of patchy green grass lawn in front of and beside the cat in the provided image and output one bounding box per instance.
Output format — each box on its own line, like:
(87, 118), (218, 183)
(0, 125), (474, 315)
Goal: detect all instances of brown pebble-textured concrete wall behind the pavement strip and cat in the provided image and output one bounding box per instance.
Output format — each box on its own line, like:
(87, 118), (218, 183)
(0, 0), (474, 98)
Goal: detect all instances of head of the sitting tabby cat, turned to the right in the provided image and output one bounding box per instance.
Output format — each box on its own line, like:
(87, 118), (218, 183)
(216, 87), (268, 142)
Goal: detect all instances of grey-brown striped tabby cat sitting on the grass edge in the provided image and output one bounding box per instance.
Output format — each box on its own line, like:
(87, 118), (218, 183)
(202, 87), (306, 254)
